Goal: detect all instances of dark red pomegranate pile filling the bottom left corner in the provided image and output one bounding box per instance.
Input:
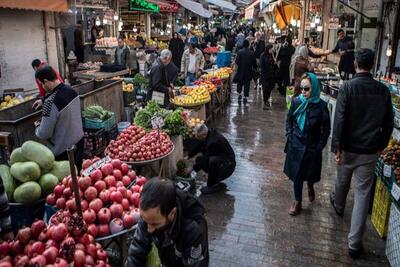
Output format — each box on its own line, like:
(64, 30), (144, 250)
(0, 219), (110, 267)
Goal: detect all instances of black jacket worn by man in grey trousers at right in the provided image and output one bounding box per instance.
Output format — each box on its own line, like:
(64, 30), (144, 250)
(332, 73), (393, 154)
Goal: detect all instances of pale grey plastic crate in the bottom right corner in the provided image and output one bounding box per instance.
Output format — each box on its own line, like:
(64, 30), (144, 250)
(386, 203), (400, 266)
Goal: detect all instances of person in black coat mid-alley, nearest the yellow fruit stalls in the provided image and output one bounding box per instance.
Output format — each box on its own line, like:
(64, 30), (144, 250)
(233, 40), (257, 103)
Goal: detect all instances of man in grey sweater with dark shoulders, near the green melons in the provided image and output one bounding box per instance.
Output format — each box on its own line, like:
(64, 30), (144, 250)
(35, 66), (83, 170)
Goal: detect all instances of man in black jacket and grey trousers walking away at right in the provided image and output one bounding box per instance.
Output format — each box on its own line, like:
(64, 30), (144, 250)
(330, 48), (393, 258)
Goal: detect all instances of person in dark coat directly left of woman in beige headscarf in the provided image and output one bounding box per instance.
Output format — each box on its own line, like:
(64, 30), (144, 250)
(277, 36), (296, 95)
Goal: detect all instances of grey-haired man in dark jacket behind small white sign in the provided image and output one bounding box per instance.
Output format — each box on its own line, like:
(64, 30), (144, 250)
(148, 49), (179, 107)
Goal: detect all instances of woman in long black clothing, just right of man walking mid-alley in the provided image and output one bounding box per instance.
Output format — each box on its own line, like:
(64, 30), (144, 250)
(260, 44), (278, 110)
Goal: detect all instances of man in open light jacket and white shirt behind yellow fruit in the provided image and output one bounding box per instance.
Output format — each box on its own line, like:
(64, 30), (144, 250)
(181, 43), (204, 85)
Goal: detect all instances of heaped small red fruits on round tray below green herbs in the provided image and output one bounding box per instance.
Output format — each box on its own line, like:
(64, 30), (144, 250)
(106, 124), (173, 162)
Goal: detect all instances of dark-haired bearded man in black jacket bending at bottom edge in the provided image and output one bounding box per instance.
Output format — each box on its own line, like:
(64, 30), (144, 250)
(126, 178), (209, 267)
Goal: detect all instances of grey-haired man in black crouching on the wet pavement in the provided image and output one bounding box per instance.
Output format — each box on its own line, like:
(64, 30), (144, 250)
(188, 124), (236, 194)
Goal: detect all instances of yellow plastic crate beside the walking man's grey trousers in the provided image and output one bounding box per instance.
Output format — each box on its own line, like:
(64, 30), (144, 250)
(371, 178), (391, 238)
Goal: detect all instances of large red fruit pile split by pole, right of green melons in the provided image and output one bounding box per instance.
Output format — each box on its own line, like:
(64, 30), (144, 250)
(46, 159), (147, 237)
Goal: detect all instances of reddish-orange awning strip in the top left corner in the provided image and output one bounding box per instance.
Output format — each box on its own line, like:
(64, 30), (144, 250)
(0, 0), (68, 12)
